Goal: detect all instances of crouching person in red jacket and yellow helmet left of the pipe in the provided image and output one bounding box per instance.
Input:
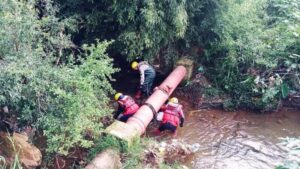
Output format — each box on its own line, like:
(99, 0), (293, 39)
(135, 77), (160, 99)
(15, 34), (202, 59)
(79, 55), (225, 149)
(114, 93), (140, 122)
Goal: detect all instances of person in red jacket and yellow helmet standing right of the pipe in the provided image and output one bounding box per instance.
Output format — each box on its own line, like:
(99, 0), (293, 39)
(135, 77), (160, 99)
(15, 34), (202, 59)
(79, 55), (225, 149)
(156, 97), (184, 137)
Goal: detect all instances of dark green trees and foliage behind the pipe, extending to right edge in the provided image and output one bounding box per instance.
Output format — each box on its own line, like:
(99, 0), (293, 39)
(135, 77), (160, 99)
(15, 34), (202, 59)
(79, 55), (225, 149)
(57, 0), (300, 110)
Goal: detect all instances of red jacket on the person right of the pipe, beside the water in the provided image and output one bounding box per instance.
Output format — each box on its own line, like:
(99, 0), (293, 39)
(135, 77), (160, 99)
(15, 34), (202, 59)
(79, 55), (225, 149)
(162, 103), (184, 127)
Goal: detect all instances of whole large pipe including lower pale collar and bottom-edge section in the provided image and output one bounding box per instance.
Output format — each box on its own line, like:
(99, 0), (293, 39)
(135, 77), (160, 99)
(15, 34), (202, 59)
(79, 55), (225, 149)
(85, 66), (186, 169)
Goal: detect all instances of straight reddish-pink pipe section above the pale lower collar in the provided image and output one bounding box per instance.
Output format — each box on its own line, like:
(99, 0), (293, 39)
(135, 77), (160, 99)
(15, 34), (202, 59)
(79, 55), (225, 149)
(127, 66), (186, 135)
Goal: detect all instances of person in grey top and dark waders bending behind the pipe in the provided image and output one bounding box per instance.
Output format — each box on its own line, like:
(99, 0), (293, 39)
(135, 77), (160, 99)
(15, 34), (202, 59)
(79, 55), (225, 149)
(131, 61), (156, 99)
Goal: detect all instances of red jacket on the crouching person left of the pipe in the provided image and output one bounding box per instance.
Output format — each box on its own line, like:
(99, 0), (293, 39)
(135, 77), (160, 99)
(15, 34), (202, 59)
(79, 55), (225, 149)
(118, 96), (140, 115)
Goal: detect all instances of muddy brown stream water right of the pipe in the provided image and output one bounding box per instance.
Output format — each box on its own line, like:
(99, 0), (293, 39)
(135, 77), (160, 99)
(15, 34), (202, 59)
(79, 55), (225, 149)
(178, 109), (300, 169)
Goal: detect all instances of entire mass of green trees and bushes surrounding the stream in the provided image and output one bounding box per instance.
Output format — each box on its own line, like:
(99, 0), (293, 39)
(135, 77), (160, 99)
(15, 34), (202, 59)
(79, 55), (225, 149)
(0, 0), (300, 167)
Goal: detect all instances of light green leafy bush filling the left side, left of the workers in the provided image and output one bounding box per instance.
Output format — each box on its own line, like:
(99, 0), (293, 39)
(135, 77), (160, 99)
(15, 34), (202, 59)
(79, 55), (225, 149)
(0, 0), (117, 154)
